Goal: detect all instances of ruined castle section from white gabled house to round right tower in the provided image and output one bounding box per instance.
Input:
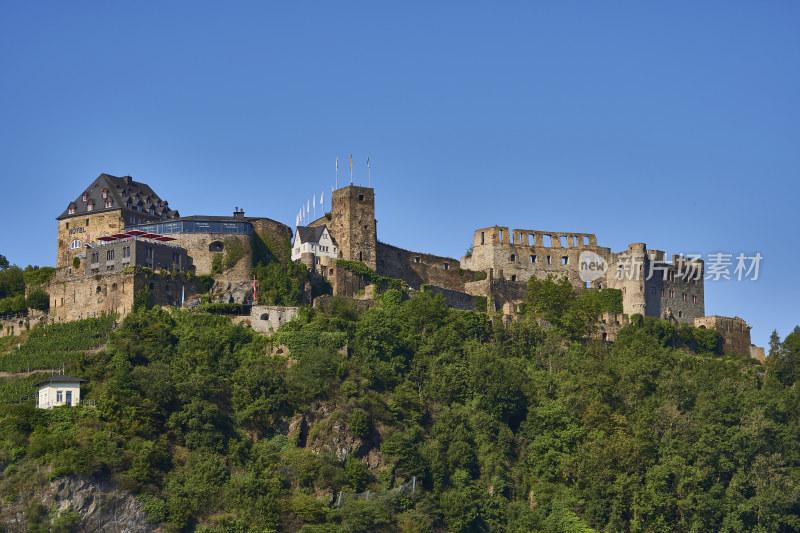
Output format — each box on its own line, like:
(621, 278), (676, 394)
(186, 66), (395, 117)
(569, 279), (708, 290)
(292, 185), (705, 324)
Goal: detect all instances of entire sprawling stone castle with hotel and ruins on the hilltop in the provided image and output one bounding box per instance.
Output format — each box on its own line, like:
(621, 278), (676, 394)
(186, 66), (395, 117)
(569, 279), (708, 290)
(40, 174), (763, 357)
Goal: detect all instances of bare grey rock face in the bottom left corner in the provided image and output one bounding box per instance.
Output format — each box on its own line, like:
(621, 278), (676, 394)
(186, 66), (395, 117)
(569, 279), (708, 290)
(3, 476), (156, 533)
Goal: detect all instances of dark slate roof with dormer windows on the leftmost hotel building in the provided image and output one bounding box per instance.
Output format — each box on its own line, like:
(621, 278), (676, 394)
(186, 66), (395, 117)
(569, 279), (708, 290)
(57, 174), (180, 220)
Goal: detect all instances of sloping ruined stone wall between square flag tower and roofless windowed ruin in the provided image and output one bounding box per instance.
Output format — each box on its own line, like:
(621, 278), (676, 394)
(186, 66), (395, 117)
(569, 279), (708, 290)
(376, 242), (471, 293)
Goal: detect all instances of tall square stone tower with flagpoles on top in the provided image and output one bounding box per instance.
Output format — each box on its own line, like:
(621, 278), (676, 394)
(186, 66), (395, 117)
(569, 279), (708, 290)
(330, 185), (378, 270)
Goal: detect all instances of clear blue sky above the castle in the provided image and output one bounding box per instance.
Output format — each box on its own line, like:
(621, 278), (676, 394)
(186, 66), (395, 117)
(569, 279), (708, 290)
(0, 1), (800, 345)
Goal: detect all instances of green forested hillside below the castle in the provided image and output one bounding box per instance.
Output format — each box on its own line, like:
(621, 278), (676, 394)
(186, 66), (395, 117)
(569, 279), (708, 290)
(0, 281), (800, 533)
